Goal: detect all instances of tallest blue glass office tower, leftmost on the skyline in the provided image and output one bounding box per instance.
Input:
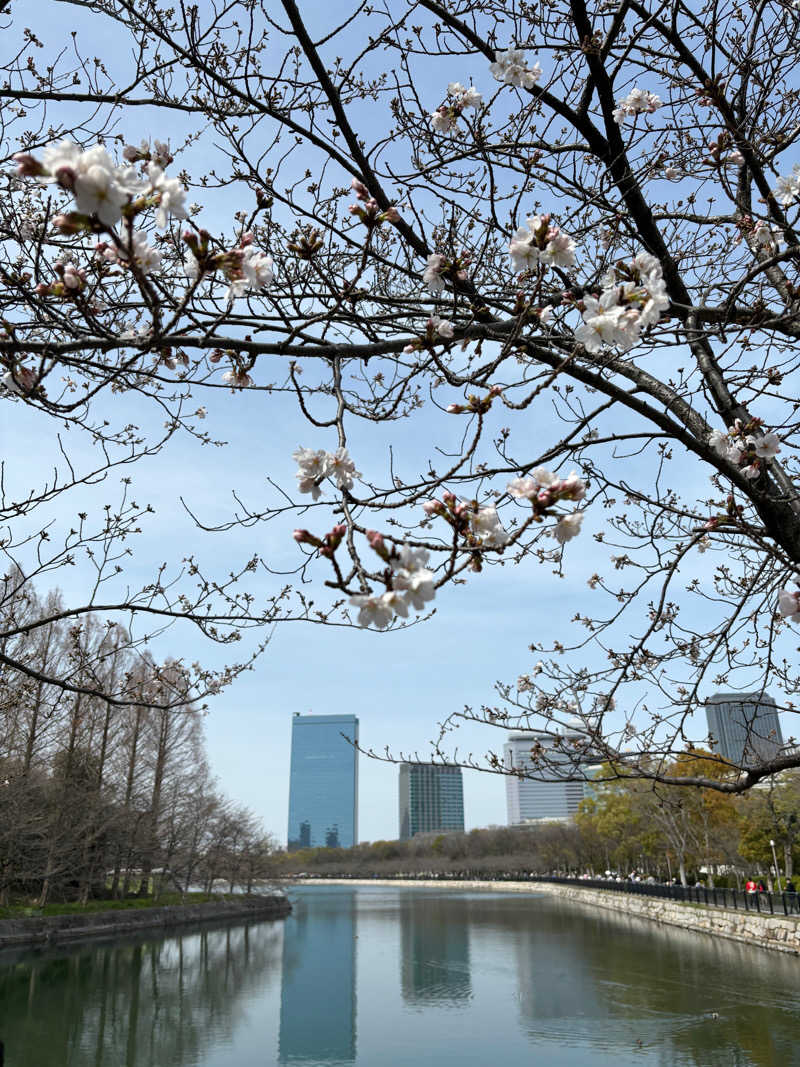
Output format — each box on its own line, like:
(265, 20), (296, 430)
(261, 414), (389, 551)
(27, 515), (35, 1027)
(288, 714), (358, 849)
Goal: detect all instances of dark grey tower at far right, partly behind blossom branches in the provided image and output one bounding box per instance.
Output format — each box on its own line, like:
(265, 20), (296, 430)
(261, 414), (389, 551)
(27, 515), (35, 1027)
(705, 692), (783, 767)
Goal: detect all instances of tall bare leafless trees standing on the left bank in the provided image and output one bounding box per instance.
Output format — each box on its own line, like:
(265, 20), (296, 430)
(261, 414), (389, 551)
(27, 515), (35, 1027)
(0, 588), (273, 907)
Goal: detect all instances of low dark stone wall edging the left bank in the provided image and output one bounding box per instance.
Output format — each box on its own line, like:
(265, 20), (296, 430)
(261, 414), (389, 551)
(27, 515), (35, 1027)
(0, 895), (291, 949)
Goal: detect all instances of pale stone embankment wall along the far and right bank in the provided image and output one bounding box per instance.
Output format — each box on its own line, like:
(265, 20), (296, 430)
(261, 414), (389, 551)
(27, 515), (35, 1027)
(292, 878), (800, 956)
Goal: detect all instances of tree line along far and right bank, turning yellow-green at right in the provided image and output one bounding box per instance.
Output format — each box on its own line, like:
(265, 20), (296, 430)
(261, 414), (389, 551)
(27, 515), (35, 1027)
(275, 751), (800, 888)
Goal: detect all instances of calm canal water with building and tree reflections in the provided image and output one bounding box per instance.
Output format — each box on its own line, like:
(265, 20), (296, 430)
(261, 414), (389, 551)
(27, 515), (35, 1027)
(0, 886), (800, 1067)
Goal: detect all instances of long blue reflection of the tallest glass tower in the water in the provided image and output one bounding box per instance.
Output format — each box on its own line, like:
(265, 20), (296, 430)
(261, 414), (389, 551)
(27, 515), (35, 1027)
(278, 891), (355, 1064)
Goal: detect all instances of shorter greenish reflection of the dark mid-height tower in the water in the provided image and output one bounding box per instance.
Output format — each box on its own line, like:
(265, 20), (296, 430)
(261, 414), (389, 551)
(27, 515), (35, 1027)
(400, 895), (473, 1004)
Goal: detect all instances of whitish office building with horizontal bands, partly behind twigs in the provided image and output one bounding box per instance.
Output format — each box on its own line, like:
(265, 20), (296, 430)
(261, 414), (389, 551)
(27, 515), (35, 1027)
(502, 730), (596, 826)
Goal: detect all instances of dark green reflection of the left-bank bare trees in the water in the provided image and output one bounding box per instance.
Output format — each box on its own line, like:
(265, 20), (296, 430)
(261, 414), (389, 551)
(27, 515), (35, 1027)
(0, 923), (283, 1067)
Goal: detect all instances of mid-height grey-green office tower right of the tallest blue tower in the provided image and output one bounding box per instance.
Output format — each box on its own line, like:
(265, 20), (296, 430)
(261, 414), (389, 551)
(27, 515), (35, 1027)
(399, 763), (464, 841)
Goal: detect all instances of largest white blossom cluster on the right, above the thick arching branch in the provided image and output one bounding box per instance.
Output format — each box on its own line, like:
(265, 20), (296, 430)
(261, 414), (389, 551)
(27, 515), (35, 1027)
(575, 252), (670, 352)
